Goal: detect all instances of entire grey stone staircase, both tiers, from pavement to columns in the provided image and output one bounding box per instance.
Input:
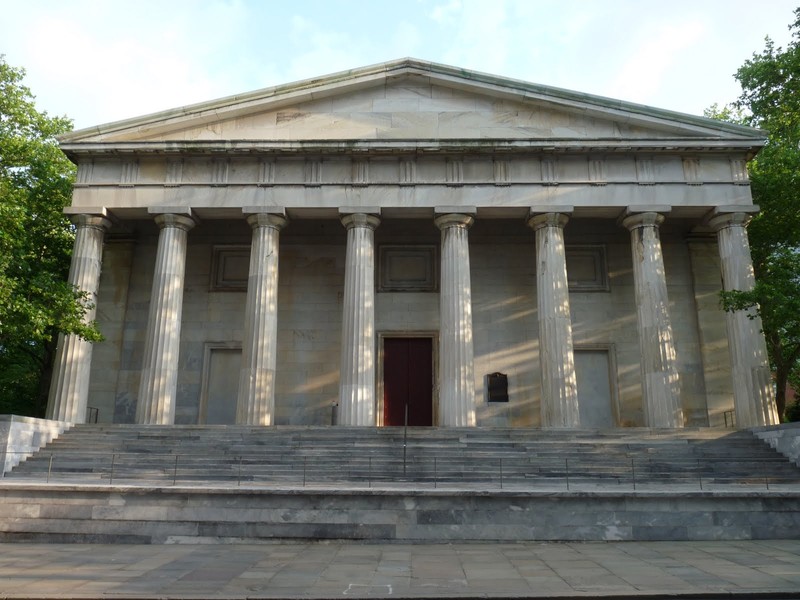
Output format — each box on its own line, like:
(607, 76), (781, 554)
(0, 425), (800, 543)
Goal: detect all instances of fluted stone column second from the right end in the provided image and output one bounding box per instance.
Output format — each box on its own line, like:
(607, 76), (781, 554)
(622, 207), (683, 428)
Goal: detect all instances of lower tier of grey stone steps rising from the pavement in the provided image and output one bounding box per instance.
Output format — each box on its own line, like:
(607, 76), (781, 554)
(0, 485), (800, 543)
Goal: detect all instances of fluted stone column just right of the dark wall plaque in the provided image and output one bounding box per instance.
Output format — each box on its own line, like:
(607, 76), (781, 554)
(528, 207), (580, 427)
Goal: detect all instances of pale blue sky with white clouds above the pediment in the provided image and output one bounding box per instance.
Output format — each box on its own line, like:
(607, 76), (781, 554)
(0, 0), (800, 129)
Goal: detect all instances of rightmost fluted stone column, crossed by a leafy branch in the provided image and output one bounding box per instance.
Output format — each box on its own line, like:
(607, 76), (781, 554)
(709, 207), (779, 428)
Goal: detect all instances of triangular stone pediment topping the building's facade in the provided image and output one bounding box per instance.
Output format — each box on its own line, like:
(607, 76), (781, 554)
(62, 59), (763, 146)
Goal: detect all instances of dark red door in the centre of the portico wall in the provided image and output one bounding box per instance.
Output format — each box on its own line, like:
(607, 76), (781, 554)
(383, 338), (433, 426)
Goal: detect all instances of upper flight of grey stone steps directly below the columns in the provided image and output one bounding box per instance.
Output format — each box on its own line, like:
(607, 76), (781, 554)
(6, 425), (800, 489)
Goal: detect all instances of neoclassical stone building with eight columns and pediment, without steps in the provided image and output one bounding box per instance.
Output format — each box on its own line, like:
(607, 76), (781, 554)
(48, 59), (777, 428)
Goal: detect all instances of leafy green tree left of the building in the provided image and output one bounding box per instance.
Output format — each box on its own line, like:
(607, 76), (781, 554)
(0, 55), (100, 416)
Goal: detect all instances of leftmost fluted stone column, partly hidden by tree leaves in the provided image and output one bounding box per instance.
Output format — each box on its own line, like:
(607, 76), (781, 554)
(47, 210), (111, 423)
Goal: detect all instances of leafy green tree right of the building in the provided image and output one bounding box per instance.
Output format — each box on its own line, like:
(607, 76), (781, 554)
(706, 9), (800, 415)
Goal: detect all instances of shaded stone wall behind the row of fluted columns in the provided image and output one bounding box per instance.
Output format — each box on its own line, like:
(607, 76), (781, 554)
(89, 218), (732, 427)
